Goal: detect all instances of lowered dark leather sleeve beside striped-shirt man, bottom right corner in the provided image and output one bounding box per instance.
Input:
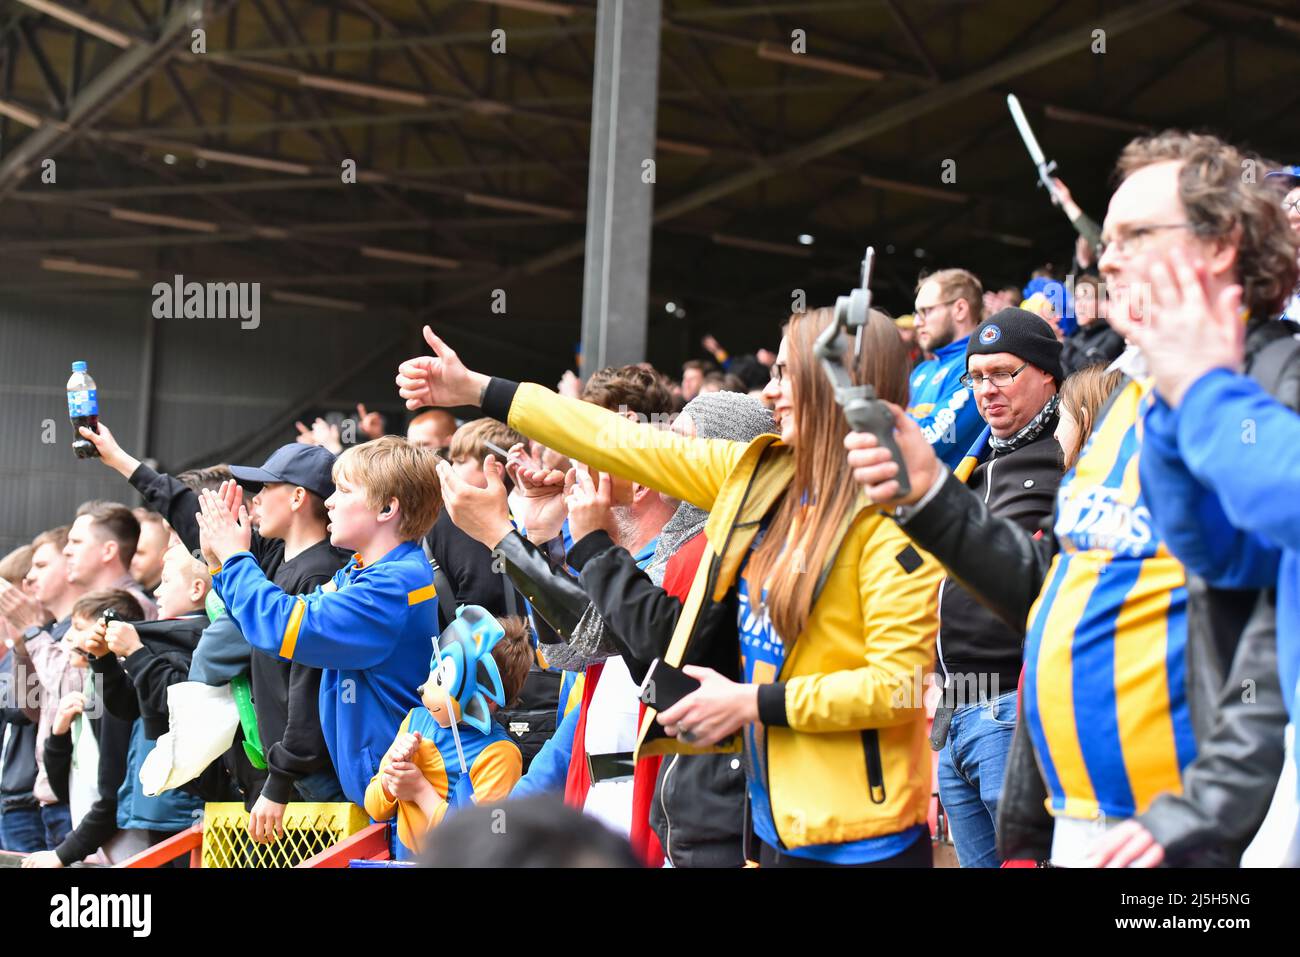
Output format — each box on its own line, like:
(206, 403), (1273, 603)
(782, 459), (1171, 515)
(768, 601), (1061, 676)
(1138, 593), (1287, 867)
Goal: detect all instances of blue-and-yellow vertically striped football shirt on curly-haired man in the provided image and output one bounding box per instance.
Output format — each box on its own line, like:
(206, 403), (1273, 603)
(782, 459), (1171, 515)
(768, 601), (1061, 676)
(1023, 381), (1196, 818)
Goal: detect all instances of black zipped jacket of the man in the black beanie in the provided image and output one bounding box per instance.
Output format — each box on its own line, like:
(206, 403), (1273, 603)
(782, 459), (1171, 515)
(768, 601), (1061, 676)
(939, 417), (1061, 691)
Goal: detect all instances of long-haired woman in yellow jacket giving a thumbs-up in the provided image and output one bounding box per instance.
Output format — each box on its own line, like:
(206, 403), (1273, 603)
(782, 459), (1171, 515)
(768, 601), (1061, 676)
(397, 309), (943, 867)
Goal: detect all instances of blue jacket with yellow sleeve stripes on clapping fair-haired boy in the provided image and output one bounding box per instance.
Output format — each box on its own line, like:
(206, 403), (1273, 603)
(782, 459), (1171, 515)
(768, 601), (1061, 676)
(212, 542), (439, 805)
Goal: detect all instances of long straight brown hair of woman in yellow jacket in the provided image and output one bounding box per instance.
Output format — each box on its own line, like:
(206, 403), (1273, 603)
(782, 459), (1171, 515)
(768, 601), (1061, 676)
(745, 308), (910, 648)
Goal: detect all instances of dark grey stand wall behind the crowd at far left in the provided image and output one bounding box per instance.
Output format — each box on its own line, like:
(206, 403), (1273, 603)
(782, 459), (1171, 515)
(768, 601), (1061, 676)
(0, 296), (419, 554)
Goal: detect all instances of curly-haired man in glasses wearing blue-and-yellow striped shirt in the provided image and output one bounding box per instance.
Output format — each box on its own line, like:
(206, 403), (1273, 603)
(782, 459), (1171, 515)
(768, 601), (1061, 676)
(845, 131), (1296, 866)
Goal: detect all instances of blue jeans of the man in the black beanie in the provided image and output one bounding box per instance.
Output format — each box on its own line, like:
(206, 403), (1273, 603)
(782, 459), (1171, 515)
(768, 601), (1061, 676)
(939, 692), (1015, 867)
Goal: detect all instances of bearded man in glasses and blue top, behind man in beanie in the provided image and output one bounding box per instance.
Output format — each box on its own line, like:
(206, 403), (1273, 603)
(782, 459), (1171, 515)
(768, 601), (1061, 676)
(907, 269), (984, 467)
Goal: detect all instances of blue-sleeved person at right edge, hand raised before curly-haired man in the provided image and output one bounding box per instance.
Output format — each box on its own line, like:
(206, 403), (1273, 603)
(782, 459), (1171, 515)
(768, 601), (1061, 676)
(1104, 166), (1300, 866)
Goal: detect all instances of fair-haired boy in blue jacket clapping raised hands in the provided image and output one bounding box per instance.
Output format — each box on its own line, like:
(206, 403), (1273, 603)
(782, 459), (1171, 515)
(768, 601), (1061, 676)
(198, 436), (442, 805)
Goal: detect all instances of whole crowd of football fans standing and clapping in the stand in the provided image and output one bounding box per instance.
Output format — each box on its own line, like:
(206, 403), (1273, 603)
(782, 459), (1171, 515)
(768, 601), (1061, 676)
(0, 131), (1300, 867)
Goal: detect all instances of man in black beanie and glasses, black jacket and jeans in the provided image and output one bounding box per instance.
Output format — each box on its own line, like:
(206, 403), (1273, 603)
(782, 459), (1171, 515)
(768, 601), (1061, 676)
(931, 308), (1062, 867)
